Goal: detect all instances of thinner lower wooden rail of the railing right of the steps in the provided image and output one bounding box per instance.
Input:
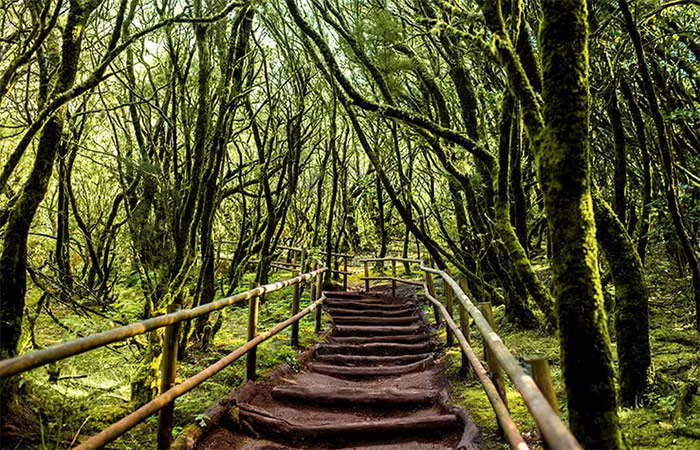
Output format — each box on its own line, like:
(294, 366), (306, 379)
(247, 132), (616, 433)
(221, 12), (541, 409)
(423, 284), (529, 450)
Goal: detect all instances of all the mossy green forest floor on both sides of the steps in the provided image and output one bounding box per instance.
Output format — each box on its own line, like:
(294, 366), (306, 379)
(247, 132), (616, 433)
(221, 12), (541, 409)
(6, 255), (700, 450)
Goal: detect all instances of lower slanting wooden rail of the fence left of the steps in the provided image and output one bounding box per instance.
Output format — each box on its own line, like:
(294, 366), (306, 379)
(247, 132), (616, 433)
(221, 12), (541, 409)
(74, 296), (326, 450)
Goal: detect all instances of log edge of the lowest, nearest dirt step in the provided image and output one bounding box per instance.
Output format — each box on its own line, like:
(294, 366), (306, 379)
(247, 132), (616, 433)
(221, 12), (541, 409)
(239, 406), (460, 447)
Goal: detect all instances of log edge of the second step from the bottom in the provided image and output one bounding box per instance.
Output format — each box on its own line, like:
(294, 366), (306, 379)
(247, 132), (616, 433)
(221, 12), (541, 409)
(272, 385), (440, 407)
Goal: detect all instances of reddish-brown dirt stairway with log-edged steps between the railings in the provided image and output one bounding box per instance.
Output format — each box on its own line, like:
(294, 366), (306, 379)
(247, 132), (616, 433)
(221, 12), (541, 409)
(197, 292), (478, 450)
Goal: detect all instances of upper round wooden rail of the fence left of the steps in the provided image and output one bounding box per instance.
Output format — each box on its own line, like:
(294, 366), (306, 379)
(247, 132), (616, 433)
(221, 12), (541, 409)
(0, 267), (328, 379)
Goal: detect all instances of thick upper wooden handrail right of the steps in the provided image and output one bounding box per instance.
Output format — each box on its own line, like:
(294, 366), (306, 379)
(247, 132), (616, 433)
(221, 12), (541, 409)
(421, 263), (582, 450)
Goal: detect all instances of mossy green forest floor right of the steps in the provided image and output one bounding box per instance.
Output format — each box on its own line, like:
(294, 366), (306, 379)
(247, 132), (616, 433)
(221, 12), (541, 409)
(439, 253), (700, 450)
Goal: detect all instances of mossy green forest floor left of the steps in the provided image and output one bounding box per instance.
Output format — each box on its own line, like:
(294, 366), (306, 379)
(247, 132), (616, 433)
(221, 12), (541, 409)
(6, 272), (328, 450)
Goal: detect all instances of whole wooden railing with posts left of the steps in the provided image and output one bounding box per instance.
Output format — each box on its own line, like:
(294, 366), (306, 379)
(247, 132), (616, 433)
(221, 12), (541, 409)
(0, 261), (328, 450)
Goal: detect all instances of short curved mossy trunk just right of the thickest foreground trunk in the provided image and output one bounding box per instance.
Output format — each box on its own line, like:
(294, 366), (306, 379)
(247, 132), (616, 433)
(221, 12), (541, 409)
(593, 187), (651, 406)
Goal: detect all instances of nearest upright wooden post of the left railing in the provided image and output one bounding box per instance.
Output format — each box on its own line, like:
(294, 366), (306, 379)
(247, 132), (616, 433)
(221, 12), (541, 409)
(158, 304), (180, 449)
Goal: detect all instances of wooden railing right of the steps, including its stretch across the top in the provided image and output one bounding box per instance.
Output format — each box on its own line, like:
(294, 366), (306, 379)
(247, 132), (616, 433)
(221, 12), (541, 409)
(362, 258), (582, 450)
